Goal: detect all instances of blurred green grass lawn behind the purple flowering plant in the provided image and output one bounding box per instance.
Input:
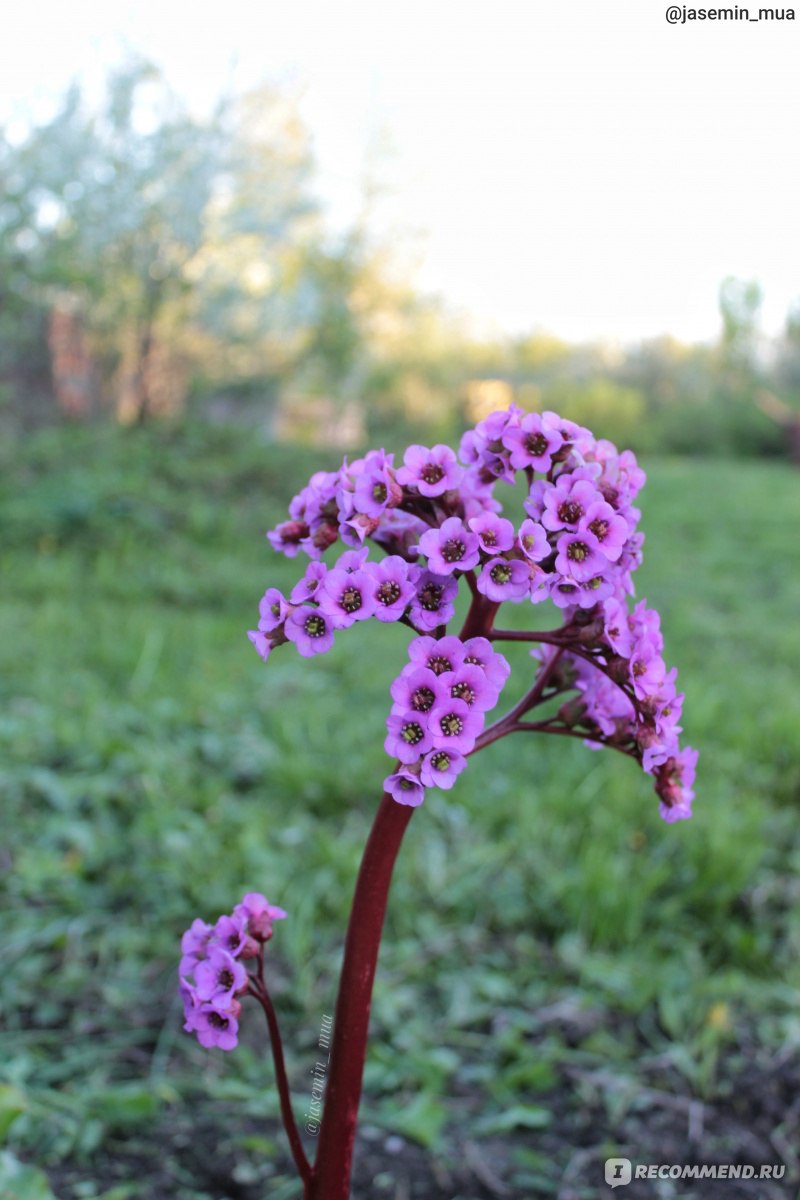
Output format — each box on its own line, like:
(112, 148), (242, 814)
(0, 428), (800, 1196)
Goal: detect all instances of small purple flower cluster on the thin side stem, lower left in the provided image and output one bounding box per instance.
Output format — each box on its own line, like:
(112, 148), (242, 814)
(179, 892), (285, 1050)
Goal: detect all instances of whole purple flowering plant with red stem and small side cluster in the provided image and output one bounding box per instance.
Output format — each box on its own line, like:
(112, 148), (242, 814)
(181, 406), (697, 1200)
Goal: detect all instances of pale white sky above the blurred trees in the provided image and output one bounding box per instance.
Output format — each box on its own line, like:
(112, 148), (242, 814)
(0, 0), (800, 341)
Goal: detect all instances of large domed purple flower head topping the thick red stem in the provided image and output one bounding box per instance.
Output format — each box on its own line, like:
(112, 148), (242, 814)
(248, 406), (697, 821)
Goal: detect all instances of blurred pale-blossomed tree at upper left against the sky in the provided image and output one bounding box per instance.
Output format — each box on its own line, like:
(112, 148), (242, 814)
(7, 60), (321, 421)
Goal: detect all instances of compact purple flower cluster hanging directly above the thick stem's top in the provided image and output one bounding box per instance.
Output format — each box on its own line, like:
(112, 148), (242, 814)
(384, 637), (511, 806)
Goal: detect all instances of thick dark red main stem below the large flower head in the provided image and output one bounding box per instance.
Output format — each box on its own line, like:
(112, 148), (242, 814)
(306, 793), (414, 1200)
